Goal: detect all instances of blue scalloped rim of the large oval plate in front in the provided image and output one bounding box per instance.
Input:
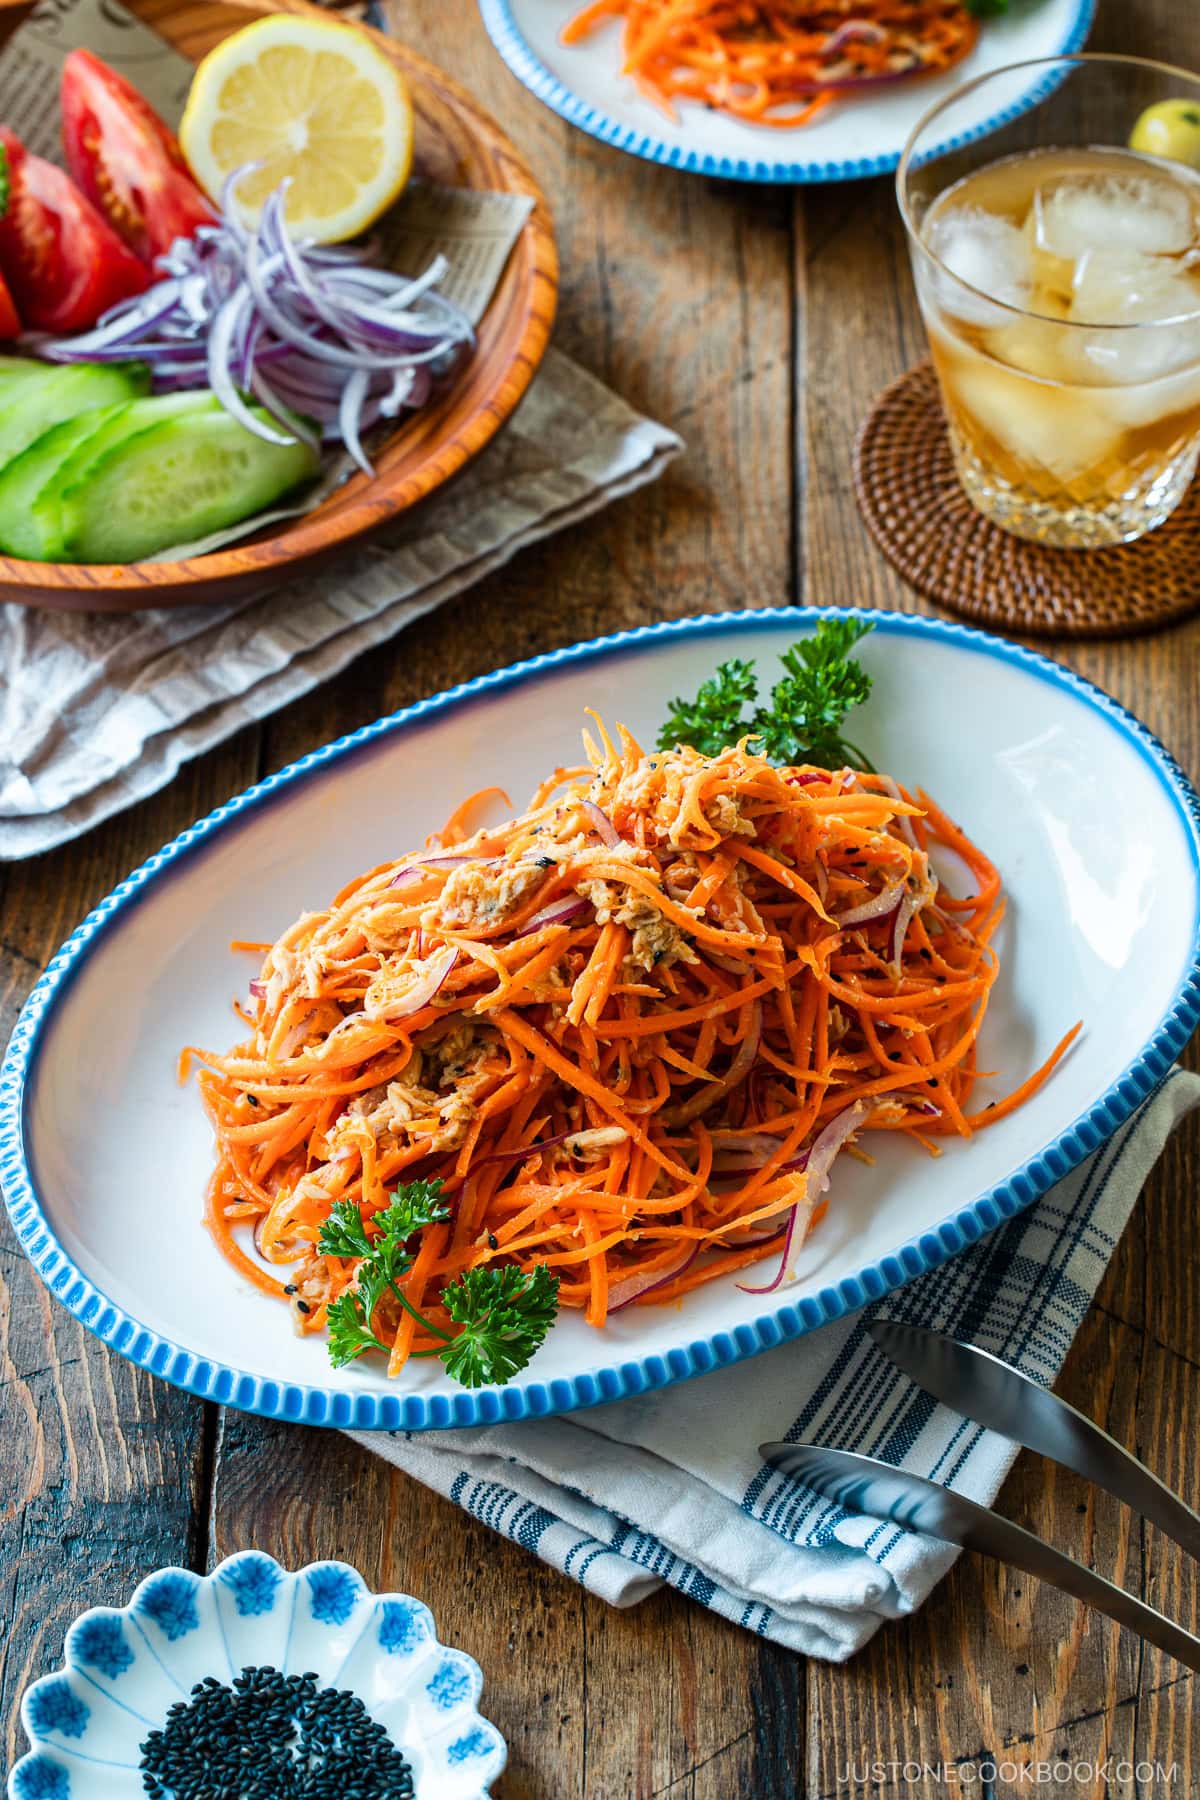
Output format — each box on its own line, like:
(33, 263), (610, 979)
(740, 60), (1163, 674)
(0, 607), (1200, 1431)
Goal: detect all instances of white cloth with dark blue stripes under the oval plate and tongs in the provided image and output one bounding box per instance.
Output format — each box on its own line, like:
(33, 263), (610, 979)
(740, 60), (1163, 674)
(354, 1069), (1200, 1661)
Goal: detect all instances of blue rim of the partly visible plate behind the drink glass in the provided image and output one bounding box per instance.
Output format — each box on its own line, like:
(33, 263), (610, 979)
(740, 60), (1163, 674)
(479, 0), (1097, 187)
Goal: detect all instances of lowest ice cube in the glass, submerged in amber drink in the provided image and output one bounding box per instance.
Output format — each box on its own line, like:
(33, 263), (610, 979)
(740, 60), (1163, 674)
(954, 356), (1121, 482)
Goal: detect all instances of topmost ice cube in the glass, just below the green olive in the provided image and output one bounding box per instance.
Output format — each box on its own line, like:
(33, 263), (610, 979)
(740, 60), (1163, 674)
(1033, 173), (1195, 263)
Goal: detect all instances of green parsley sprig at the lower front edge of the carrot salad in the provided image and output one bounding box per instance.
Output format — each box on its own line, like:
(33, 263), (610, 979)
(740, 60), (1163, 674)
(317, 1181), (558, 1388)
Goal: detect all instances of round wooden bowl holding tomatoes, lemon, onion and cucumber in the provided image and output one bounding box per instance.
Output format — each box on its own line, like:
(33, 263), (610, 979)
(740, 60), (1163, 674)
(0, 0), (558, 612)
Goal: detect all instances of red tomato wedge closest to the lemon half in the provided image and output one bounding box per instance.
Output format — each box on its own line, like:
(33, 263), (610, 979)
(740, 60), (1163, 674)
(63, 50), (216, 263)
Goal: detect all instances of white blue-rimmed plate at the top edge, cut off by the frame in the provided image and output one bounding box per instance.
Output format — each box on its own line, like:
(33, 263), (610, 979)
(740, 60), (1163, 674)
(479, 0), (1096, 182)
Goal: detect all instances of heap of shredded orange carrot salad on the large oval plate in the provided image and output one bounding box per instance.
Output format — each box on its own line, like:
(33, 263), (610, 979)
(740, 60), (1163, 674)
(184, 724), (1079, 1372)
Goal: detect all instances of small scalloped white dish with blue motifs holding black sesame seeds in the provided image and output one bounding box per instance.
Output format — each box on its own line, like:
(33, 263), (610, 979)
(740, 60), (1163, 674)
(7, 1550), (506, 1800)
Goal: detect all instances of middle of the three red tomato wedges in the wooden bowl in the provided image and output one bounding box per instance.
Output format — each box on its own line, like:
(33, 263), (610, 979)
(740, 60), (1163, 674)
(0, 126), (151, 331)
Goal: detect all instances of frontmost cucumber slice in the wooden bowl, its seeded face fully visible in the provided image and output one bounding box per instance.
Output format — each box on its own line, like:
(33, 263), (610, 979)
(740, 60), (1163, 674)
(63, 407), (320, 563)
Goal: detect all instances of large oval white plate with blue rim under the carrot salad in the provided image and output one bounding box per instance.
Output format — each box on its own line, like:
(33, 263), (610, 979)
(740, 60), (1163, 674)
(0, 608), (1200, 1431)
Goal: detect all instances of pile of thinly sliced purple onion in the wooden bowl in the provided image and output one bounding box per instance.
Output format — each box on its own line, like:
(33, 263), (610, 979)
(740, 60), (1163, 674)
(45, 169), (475, 473)
